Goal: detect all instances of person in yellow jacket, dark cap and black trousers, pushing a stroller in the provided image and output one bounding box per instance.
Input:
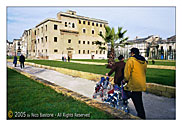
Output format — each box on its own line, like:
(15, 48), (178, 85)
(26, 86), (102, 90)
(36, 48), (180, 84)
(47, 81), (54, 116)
(123, 48), (147, 119)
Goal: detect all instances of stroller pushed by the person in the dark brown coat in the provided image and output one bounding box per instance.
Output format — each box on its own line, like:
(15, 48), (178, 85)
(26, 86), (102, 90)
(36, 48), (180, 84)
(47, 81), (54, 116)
(93, 77), (111, 101)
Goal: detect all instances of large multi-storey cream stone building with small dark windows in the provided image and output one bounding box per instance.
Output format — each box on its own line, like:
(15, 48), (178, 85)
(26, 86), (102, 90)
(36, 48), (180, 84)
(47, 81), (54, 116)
(22, 10), (108, 59)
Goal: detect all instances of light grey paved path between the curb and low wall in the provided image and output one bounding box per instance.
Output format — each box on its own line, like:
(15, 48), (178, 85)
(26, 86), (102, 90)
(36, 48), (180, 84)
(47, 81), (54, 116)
(7, 62), (176, 119)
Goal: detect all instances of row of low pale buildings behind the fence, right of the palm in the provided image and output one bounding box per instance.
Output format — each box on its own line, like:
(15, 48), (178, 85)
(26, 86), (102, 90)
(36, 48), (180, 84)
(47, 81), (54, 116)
(115, 35), (176, 60)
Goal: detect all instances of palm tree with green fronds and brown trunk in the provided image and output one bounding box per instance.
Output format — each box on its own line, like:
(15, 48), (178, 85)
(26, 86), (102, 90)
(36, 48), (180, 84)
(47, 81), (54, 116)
(96, 26), (128, 68)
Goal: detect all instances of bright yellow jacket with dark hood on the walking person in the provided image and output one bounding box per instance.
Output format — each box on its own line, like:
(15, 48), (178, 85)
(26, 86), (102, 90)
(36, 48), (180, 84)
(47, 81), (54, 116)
(124, 56), (147, 91)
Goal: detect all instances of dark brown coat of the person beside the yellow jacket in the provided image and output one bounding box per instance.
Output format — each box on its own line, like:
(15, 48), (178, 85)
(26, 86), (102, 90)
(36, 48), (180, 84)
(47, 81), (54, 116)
(108, 61), (125, 85)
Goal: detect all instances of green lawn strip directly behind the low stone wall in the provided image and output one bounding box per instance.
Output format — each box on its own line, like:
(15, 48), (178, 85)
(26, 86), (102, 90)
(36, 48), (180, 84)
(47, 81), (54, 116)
(27, 60), (176, 86)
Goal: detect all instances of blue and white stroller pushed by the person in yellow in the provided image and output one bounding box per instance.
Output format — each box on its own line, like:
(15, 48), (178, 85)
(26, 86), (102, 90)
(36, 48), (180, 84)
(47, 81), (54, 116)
(104, 83), (129, 113)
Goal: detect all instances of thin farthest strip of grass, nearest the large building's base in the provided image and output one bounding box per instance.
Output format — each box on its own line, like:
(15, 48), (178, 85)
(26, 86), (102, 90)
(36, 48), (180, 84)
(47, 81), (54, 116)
(72, 59), (176, 66)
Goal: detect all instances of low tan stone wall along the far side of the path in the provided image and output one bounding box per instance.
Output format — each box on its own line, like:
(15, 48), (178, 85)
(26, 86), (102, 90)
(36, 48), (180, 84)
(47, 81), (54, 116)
(22, 62), (176, 98)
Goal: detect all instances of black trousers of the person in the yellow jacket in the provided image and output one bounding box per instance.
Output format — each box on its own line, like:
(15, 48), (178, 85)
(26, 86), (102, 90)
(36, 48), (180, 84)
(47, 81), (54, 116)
(126, 91), (146, 119)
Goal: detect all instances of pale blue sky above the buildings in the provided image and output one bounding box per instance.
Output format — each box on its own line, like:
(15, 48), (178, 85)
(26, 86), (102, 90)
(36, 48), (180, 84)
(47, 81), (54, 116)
(7, 7), (176, 41)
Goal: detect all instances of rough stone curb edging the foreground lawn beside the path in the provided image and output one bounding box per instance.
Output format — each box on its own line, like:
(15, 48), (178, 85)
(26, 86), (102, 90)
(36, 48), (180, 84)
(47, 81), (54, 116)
(8, 66), (140, 120)
